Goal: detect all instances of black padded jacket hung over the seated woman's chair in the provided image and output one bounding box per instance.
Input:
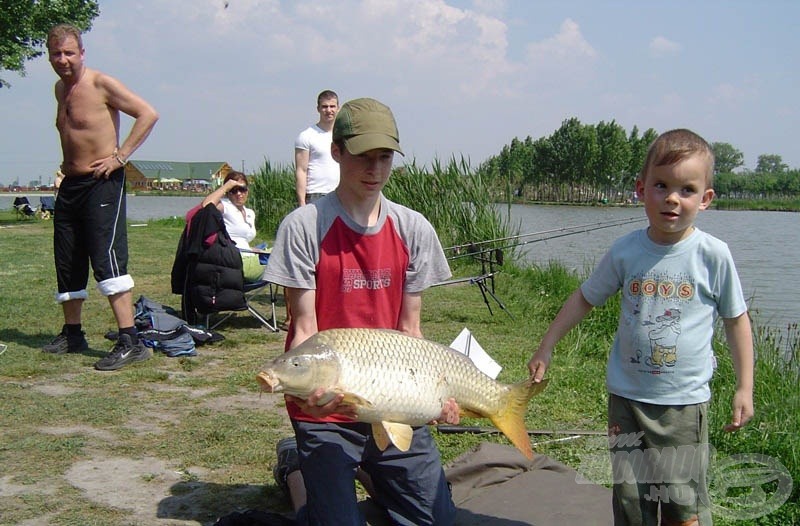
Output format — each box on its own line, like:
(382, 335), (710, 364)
(171, 204), (247, 324)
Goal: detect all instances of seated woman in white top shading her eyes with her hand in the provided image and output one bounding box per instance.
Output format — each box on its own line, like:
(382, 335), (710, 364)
(202, 171), (264, 281)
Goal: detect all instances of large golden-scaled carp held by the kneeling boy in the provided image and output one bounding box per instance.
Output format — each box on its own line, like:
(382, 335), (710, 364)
(257, 329), (546, 458)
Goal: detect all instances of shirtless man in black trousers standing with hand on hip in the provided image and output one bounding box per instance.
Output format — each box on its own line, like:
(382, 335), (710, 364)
(43, 24), (158, 371)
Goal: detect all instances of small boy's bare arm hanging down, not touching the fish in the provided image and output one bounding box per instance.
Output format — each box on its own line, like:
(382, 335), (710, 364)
(722, 312), (754, 432)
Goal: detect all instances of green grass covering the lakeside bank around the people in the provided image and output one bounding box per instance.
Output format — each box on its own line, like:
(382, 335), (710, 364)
(0, 207), (800, 526)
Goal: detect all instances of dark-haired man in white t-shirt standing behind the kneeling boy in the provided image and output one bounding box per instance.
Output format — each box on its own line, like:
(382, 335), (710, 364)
(294, 90), (339, 206)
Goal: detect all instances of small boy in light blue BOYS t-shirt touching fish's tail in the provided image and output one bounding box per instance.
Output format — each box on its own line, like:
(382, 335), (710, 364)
(528, 129), (753, 526)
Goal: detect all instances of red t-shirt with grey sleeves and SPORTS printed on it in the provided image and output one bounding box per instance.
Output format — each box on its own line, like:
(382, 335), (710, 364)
(265, 193), (450, 422)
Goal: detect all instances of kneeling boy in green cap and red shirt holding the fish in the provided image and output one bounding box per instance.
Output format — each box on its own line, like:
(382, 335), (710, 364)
(265, 98), (458, 525)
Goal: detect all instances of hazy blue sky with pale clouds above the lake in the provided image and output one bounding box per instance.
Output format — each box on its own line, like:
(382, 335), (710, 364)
(0, 0), (800, 188)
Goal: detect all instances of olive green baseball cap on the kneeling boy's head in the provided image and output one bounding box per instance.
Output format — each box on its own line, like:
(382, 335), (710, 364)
(333, 98), (404, 155)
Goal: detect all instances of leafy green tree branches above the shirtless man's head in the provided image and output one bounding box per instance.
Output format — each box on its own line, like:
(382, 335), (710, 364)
(0, 0), (100, 87)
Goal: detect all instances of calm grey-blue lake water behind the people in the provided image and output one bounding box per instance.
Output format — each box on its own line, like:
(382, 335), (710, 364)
(0, 194), (800, 329)
